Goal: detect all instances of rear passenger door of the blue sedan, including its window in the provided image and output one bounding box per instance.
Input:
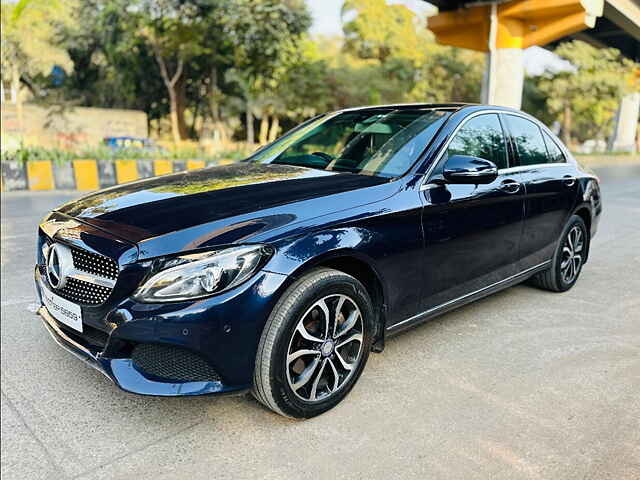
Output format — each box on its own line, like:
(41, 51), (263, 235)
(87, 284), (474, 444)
(502, 114), (578, 270)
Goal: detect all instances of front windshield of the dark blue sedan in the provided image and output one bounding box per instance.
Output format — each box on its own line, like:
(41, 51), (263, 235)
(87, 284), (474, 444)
(249, 108), (450, 178)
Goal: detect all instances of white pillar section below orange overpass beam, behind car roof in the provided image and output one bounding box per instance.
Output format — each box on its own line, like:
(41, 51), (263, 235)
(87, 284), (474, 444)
(481, 48), (524, 108)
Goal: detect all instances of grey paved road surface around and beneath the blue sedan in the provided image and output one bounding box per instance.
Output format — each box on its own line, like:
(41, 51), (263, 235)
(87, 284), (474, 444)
(1, 167), (640, 480)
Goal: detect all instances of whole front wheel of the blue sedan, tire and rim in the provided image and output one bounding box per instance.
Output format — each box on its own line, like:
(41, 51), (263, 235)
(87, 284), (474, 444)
(252, 268), (374, 418)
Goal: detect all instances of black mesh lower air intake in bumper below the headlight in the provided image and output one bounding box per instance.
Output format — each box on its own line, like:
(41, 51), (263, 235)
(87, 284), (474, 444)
(131, 343), (220, 382)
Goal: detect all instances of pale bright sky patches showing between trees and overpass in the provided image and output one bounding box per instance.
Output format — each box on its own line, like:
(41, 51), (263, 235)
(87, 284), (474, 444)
(306, 0), (564, 75)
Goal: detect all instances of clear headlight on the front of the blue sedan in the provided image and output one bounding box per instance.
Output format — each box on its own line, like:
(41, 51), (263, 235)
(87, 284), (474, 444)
(133, 245), (272, 302)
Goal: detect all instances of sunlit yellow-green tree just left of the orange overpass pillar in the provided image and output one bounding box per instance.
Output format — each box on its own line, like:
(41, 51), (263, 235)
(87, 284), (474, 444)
(336, 0), (484, 104)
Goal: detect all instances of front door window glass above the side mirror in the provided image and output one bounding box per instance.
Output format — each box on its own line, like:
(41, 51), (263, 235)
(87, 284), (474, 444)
(447, 114), (507, 168)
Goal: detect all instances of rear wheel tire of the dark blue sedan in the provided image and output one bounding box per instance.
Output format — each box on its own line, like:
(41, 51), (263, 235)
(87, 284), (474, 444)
(530, 215), (590, 292)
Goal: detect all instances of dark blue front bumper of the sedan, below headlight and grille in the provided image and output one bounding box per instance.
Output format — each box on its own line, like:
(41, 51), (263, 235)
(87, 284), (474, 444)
(36, 269), (286, 396)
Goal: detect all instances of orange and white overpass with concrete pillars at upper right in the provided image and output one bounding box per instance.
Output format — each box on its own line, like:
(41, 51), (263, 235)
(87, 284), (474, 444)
(427, 0), (640, 151)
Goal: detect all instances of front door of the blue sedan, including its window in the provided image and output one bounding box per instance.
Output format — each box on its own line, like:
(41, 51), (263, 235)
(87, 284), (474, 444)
(423, 113), (524, 310)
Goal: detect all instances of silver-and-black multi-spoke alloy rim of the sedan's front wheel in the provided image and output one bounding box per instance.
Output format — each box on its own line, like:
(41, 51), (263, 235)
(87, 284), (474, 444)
(286, 294), (364, 402)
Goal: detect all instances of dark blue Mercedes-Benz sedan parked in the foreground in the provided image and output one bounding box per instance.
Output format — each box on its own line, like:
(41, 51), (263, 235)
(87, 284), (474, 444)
(35, 104), (602, 418)
